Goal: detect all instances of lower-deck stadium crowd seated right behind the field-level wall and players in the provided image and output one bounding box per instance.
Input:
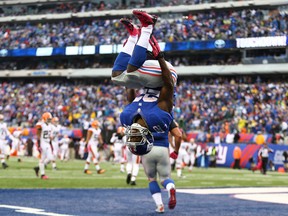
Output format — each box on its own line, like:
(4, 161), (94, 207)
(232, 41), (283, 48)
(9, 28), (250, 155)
(0, 76), (288, 143)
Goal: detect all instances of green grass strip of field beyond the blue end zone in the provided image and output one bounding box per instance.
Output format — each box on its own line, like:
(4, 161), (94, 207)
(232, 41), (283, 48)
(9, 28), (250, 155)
(0, 157), (288, 189)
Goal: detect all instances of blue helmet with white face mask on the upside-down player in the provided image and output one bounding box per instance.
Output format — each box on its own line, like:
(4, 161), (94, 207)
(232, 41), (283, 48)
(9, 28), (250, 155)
(125, 123), (154, 155)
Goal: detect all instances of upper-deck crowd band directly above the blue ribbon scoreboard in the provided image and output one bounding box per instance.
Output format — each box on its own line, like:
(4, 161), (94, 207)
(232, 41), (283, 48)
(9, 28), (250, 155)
(0, 9), (288, 49)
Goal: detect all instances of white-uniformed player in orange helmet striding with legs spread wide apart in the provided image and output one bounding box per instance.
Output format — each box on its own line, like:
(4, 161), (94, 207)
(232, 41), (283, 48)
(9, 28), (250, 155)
(84, 120), (105, 174)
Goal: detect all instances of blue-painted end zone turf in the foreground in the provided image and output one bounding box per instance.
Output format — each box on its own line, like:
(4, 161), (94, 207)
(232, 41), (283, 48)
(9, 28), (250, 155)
(0, 189), (288, 216)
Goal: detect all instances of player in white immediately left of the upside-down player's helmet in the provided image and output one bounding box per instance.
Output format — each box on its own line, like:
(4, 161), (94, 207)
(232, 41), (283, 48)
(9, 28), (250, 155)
(110, 127), (125, 172)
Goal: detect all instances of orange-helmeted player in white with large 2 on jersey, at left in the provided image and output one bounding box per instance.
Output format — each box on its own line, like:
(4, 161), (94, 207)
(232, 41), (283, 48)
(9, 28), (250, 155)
(34, 112), (53, 180)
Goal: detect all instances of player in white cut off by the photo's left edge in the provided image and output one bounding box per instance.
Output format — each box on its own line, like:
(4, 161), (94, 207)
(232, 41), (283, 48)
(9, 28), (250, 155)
(0, 114), (13, 169)
